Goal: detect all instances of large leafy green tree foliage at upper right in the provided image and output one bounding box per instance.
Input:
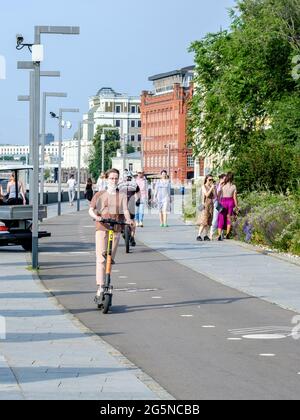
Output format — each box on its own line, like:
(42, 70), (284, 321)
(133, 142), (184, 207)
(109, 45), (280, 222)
(188, 0), (300, 193)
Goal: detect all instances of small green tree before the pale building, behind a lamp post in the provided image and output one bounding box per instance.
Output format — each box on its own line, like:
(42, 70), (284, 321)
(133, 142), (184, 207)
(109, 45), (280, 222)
(89, 126), (120, 179)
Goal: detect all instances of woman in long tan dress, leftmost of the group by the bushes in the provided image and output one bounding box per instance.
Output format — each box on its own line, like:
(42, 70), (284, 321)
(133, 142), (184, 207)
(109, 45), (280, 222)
(197, 175), (216, 242)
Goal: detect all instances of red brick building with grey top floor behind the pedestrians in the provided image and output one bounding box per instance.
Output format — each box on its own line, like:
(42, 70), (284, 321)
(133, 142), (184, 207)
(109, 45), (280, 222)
(141, 67), (195, 182)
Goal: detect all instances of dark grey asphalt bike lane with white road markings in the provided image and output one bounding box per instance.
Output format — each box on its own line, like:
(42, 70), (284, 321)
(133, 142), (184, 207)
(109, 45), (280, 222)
(40, 211), (300, 399)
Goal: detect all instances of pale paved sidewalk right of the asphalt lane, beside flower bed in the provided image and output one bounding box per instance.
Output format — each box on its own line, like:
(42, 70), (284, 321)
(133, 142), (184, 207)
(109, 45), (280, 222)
(137, 215), (300, 313)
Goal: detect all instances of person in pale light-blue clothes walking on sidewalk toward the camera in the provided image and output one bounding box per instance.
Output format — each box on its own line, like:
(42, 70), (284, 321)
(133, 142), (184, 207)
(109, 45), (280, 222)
(154, 170), (171, 228)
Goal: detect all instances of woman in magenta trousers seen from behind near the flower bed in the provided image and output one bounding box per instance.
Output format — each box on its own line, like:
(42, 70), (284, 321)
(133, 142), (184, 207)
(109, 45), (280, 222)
(218, 172), (238, 241)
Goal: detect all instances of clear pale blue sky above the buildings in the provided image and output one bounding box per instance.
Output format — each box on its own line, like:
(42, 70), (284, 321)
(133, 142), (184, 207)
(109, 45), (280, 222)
(0, 0), (235, 144)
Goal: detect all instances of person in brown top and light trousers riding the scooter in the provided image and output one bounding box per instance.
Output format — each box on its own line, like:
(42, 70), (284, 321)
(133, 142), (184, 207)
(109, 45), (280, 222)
(89, 169), (133, 297)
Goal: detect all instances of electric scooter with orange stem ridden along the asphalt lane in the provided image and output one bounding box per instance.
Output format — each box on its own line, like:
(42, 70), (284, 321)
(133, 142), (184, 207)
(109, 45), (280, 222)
(95, 219), (129, 315)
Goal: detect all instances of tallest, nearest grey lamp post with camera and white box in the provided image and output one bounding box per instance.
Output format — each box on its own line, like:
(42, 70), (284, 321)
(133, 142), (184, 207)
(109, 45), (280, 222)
(17, 26), (80, 269)
